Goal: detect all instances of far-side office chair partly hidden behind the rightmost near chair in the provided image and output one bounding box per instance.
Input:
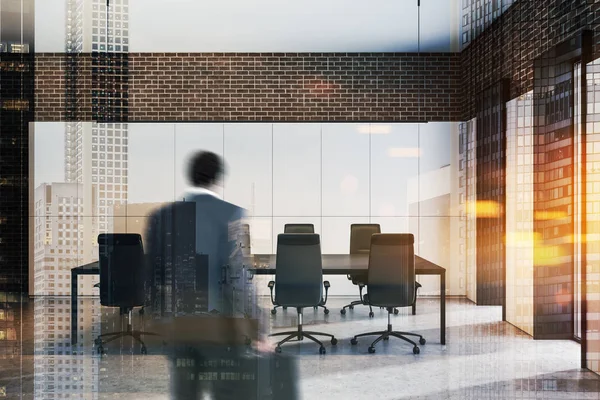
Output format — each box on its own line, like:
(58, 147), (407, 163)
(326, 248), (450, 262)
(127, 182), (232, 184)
(340, 224), (421, 318)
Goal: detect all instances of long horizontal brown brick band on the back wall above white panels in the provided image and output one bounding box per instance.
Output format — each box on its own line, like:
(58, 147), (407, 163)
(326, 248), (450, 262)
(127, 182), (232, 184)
(36, 53), (461, 122)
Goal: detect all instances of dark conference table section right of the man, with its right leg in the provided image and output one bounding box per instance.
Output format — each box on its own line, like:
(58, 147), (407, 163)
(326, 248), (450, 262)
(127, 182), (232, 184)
(247, 254), (446, 345)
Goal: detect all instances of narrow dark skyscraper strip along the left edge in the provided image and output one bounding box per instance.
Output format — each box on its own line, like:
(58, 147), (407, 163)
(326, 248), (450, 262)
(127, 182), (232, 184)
(0, 0), (35, 295)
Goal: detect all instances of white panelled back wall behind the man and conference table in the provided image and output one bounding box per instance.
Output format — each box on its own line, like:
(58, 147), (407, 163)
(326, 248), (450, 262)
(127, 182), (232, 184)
(32, 123), (467, 295)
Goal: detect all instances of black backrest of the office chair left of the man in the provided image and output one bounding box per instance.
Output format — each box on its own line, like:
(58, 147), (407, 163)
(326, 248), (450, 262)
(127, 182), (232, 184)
(98, 233), (146, 308)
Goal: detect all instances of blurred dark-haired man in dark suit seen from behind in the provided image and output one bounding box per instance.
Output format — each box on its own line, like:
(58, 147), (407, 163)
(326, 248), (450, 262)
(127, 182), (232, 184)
(147, 151), (296, 400)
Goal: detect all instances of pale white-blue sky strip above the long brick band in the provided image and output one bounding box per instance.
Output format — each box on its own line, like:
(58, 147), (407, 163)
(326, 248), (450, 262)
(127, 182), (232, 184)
(35, 0), (459, 52)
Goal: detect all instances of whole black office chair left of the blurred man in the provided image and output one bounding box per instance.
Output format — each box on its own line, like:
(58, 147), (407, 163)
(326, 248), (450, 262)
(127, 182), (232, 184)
(94, 233), (159, 355)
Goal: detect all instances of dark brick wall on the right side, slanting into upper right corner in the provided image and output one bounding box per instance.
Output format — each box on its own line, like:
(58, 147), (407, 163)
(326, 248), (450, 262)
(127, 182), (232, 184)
(460, 0), (600, 120)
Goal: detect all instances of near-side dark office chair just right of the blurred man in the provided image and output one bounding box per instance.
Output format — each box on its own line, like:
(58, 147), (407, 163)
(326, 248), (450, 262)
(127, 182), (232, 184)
(269, 233), (337, 354)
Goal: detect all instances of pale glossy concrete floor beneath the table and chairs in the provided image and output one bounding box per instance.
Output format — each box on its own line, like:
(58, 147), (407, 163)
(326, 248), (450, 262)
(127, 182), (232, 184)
(8, 298), (600, 400)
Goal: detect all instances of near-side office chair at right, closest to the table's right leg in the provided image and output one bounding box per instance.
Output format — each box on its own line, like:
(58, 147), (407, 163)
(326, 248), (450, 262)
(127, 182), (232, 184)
(350, 233), (426, 354)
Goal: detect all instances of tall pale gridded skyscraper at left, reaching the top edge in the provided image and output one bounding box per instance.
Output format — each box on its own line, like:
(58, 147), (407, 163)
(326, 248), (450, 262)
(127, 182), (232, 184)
(65, 0), (129, 263)
